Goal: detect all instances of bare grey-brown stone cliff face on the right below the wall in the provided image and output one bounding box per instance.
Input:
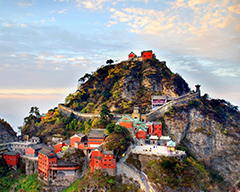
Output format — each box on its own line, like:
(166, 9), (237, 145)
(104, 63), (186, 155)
(165, 109), (240, 183)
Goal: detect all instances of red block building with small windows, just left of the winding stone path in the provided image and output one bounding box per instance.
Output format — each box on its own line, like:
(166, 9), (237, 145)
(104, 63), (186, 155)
(89, 149), (116, 175)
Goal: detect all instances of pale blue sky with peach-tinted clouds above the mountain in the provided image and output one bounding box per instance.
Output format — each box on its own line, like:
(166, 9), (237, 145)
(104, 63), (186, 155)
(0, 0), (240, 133)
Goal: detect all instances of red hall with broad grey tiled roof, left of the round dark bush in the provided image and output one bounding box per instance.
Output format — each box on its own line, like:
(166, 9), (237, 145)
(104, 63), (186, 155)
(88, 129), (106, 149)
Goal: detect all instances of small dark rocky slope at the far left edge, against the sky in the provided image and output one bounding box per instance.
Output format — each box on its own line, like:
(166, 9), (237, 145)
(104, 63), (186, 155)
(0, 118), (17, 143)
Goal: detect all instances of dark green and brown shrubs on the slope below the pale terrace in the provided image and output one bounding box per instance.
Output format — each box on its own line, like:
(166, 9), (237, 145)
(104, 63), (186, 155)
(144, 156), (228, 192)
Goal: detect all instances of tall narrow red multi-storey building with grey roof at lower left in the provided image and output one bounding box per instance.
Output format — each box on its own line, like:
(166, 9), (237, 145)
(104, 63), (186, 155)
(38, 147), (57, 178)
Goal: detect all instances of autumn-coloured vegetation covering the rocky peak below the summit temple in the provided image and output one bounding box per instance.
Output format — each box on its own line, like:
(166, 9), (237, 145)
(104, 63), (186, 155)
(65, 59), (189, 113)
